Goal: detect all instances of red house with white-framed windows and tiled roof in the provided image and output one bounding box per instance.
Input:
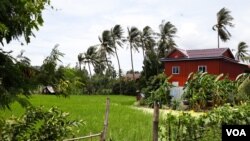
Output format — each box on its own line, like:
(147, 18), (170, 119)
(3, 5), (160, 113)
(161, 48), (248, 87)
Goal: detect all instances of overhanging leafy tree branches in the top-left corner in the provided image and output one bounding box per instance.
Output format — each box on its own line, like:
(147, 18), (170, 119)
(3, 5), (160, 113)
(0, 0), (50, 45)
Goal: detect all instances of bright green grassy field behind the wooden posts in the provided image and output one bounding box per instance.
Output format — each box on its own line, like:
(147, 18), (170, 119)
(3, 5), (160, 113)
(0, 95), (152, 141)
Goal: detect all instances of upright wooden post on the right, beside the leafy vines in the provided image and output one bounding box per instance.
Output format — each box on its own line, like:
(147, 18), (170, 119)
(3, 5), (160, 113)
(153, 101), (159, 141)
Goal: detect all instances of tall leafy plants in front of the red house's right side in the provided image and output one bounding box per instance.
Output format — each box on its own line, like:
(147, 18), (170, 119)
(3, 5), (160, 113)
(183, 73), (238, 110)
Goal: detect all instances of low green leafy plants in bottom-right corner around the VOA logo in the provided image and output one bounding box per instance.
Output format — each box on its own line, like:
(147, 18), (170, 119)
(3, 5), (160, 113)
(160, 103), (250, 141)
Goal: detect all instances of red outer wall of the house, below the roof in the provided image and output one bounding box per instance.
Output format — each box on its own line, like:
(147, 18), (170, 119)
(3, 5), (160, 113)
(165, 60), (246, 86)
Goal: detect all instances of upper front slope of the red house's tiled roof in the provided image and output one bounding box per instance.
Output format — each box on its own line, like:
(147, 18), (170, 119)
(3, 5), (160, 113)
(178, 48), (228, 58)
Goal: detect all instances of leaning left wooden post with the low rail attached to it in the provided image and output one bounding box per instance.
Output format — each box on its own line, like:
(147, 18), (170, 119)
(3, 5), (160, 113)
(63, 98), (110, 141)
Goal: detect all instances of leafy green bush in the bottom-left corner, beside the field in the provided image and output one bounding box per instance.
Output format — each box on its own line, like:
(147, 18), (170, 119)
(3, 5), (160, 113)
(0, 107), (82, 141)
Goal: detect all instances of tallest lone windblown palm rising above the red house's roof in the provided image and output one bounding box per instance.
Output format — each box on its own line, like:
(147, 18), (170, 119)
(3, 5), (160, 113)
(213, 8), (234, 48)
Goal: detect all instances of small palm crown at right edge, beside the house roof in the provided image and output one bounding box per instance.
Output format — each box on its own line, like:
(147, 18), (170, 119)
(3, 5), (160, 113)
(235, 42), (249, 62)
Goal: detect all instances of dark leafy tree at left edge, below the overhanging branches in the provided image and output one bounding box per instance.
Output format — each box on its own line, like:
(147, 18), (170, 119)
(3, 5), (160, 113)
(0, 51), (37, 108)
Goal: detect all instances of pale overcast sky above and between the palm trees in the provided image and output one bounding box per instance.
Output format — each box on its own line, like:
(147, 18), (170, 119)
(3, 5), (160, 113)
(4, 0), (250, 72)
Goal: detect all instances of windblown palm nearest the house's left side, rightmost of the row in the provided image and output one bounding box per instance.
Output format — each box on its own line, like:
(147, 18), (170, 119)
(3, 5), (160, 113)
(157, 20), (177, 58)
